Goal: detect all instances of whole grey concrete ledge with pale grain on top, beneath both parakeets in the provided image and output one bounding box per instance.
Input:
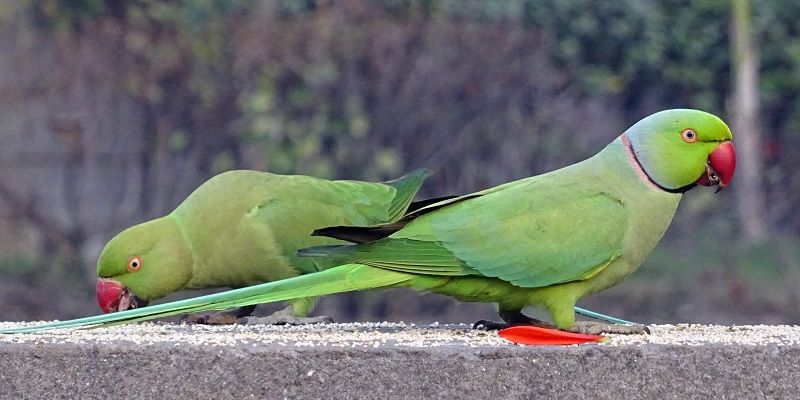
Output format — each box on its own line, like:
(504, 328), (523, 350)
(0, 322), (800, 400)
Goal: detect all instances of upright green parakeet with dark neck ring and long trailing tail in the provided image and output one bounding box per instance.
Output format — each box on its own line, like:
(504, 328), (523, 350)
(1, 109), (736, 333)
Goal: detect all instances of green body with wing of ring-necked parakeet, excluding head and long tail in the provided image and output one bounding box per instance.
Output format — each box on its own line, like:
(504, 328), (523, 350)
(302, 135), (681, 327)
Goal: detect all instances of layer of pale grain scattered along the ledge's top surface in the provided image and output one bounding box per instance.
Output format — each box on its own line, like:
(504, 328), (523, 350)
(0, 322), (800, 348)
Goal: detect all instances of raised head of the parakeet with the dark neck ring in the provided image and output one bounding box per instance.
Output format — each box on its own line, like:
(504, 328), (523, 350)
(622, 109), (736, 193)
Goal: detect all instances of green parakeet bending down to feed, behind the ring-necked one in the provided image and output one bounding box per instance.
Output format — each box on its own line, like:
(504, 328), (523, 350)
(97, 170), (438, 322)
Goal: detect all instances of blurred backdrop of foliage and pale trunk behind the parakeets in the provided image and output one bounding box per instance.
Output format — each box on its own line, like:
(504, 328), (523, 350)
(0, 0), (800, 323)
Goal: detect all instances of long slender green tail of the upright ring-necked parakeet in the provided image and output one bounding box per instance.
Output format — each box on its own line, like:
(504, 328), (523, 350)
(0, 264), (413, 334)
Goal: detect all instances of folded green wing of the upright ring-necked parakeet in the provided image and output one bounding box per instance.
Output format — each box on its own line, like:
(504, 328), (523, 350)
(310, 178), (628, 287)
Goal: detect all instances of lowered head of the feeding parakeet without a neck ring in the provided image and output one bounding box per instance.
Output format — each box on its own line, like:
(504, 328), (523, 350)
(97, 216), (193, 313)
